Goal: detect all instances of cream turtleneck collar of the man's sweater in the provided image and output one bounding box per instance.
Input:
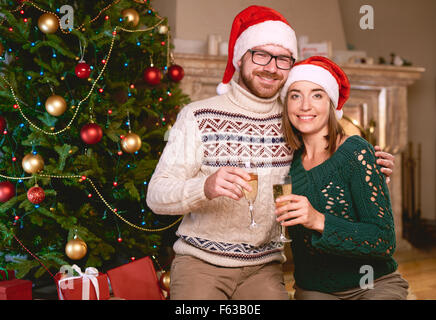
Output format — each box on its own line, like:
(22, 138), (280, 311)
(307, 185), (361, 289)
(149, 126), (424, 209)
(227, 80), (279, 113)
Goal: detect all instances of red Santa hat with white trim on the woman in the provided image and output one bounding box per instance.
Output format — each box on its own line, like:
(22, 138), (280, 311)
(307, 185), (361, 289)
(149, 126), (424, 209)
(280, 56), (350, 119)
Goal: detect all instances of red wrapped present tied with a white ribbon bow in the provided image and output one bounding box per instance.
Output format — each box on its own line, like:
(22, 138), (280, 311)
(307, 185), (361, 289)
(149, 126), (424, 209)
(55, 265), (110, 300)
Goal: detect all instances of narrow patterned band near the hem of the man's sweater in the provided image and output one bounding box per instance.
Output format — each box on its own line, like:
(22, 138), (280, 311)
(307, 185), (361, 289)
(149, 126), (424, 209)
(177, 232), (283, 261)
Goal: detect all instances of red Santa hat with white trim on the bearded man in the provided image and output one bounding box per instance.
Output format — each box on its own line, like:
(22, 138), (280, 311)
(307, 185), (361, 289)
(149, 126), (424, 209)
(217, 6), (298, 95)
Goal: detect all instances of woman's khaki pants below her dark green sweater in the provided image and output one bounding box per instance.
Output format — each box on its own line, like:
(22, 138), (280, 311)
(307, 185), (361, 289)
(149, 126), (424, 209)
(294, 272), (409, 300)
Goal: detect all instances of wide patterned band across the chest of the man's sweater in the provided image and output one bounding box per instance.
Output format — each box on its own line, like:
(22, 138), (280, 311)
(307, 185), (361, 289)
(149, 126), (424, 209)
(194, 109), (292, 168)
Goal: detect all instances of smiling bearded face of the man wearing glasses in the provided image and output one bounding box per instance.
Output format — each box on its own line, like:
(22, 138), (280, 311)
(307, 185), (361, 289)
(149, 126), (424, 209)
(238, 44), (291, 99)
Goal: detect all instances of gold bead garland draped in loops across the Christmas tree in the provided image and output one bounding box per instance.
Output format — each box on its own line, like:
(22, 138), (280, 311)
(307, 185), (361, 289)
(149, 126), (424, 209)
(0, 0), (182, 232)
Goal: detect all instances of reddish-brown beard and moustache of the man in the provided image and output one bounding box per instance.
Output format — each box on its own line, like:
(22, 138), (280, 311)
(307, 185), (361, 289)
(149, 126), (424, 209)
(240, 66), (284, 99)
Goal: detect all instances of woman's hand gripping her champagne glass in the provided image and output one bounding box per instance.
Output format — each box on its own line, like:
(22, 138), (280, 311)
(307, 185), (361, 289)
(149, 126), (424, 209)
(275, 194), (325, 233)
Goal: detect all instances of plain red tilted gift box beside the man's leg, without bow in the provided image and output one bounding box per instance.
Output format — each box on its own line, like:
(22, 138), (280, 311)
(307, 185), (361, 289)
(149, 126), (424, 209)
(107, 257), (165, 300)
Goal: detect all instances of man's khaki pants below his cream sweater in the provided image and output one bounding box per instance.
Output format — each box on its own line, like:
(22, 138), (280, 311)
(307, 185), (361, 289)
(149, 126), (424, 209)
(170, 255), (289, 300)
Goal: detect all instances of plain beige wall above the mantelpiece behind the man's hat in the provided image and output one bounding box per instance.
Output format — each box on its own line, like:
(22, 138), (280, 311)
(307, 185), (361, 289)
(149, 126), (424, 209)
(153, 0), (345, 50)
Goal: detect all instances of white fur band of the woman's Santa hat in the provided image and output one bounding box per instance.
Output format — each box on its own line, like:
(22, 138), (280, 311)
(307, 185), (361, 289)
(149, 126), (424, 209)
(280, 64), (339, 108)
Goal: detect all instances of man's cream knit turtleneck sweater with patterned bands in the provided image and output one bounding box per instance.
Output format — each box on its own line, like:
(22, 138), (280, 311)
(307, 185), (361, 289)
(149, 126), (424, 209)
(147, 81), (292, 267)
